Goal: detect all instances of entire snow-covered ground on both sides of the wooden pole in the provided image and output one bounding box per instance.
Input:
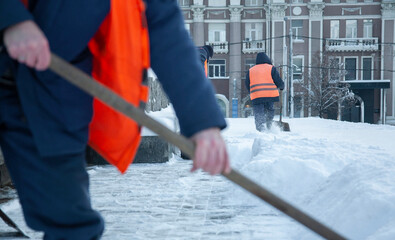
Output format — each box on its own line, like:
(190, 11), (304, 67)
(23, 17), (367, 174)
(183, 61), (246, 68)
(0, 111), (395, 240)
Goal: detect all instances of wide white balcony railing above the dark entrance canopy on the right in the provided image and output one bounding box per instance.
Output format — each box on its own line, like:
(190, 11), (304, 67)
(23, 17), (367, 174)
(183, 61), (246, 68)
(326, 38), (379, 51)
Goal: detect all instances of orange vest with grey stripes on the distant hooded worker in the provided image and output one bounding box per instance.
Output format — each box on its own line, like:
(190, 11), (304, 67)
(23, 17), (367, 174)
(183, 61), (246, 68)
(249, 64), (279, 100)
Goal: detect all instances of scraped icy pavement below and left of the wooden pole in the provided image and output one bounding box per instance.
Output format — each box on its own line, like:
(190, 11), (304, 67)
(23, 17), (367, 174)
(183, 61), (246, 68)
(0, 157), (296, 240)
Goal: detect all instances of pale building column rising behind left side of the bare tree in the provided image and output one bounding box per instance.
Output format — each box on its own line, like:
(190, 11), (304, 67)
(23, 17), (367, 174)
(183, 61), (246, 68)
(307, 0), (325, 117)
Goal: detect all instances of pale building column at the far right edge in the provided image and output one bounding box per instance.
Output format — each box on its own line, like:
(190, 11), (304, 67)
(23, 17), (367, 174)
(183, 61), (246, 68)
(381, 0), (395, 124)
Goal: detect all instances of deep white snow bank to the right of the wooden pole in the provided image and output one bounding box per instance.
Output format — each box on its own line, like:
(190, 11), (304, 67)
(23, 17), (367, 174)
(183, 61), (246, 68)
(224, 118), (395, 239)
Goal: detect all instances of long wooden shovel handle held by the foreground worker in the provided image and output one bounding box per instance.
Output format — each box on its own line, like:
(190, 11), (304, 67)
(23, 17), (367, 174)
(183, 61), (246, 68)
(49, 54), (346, 239)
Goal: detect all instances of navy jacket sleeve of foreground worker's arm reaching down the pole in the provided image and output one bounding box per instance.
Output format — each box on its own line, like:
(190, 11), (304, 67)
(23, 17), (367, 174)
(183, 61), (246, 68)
(146, 0), (226, 137)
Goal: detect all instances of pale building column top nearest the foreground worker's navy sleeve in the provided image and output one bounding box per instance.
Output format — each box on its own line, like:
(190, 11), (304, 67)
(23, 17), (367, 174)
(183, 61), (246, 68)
(191, 0), (206, 46)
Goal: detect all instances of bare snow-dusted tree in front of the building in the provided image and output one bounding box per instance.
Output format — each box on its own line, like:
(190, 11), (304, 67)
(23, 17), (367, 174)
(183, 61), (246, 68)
(300, 52), (354, 119)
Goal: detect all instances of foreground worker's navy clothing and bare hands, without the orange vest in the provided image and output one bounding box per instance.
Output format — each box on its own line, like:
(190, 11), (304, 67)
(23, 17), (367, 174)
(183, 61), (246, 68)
(0, 0), (230, 240)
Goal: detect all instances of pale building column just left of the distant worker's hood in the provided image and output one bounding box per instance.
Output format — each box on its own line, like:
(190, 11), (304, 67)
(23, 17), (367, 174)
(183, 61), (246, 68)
(228, 5), (243, 117)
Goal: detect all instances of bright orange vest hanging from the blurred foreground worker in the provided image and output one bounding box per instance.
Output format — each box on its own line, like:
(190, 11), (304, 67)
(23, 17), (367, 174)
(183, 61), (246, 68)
(88, 0), (150, 173)
